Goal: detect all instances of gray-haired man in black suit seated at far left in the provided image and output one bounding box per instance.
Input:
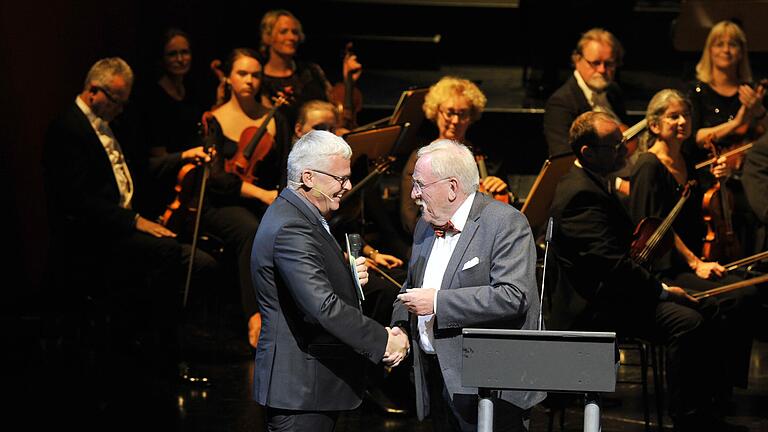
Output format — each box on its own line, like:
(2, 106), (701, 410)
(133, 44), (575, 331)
(42, 57), (215, 382)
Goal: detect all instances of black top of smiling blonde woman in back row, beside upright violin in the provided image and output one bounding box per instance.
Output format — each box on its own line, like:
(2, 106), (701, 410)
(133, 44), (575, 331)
(261, 61), (331, 125)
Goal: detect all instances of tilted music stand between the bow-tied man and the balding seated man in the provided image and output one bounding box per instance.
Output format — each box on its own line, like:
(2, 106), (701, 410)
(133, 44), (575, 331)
(520, 153), (576, 232)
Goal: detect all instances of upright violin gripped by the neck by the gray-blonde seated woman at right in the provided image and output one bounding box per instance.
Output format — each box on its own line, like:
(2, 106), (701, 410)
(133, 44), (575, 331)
(701, 138), (742, 261)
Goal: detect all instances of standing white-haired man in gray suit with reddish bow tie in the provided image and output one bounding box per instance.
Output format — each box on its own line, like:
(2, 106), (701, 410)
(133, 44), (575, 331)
(392, 140), (545, 431)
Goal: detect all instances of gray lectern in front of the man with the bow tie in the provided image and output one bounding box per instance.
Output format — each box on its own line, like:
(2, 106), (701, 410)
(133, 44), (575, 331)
(461, 328), (618, 432)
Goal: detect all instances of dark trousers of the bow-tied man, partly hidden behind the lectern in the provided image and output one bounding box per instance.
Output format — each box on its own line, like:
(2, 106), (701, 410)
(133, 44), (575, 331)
(423, 354), (530, 432)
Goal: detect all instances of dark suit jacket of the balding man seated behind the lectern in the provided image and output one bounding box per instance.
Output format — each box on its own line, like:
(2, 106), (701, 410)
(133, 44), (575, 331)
(549, 167), (661, 330)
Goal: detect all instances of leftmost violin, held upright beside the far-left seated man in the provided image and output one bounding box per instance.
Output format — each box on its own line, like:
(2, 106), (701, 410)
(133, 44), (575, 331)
(157, 111), (215, 237)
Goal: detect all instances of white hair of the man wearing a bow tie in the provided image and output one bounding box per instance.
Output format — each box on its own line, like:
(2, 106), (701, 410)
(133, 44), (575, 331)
(417, 139), (480, 194)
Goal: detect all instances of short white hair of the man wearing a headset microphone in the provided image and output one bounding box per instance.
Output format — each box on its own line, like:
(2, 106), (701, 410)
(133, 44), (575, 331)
(288, 130), (352, 189)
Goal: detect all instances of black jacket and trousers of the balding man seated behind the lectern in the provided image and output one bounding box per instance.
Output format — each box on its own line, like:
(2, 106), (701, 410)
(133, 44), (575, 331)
(548, 167), (715, 423)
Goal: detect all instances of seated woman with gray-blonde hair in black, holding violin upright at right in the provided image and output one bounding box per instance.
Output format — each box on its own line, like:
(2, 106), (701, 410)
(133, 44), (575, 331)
(629, 89), (756, 400)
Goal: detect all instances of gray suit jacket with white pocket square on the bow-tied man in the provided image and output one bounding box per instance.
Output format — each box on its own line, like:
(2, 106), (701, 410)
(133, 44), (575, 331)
(392, 193), (546, 419)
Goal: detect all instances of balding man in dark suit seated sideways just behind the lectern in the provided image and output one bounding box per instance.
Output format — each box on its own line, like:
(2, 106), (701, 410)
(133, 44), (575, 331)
(549, 112), (752, 431)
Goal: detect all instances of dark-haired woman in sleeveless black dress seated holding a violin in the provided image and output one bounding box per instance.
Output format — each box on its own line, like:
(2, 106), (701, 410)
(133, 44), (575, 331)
(202, 48), (290, 346)
